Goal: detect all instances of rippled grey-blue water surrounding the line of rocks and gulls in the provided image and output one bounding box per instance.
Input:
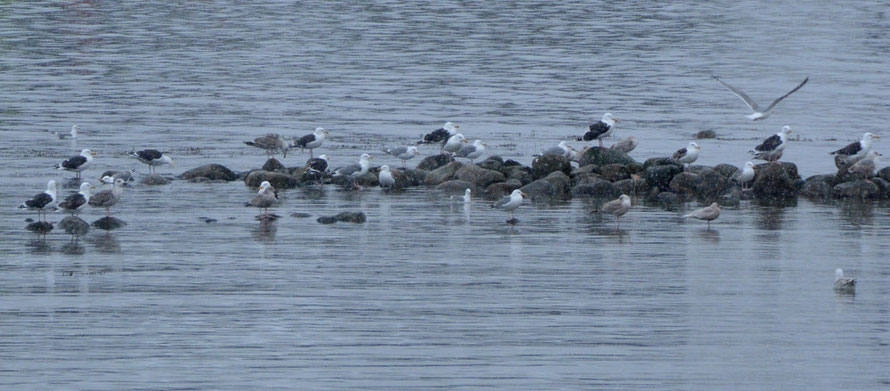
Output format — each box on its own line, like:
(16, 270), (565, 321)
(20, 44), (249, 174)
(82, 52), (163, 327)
(0, 1), (890, 390)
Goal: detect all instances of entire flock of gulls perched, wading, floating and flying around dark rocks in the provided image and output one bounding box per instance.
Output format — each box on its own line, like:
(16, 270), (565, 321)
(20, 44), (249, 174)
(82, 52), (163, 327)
(20, 76), (882, 292)
